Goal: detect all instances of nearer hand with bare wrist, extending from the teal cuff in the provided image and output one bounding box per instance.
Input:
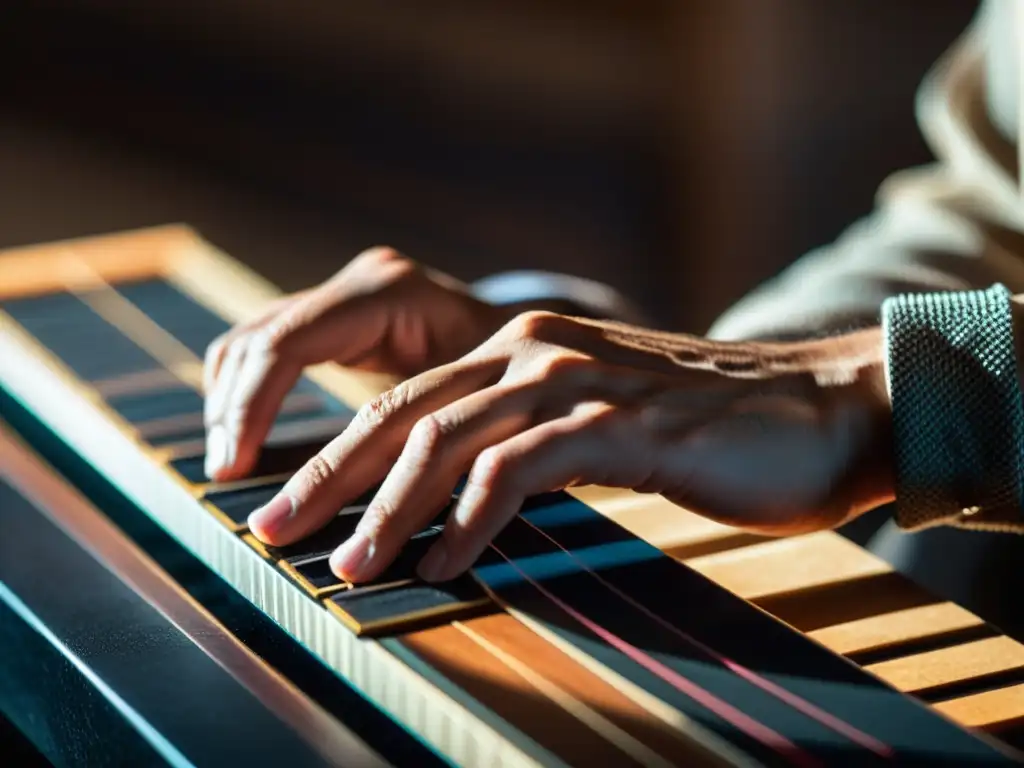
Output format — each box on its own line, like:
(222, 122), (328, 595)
(243, 312), (892, 582)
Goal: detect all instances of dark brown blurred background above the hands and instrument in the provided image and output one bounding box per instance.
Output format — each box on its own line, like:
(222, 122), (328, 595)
(0, 0), (977, 332)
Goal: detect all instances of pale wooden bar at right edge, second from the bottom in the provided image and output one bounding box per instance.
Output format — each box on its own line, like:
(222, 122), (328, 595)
(864, 637), (1024, 693)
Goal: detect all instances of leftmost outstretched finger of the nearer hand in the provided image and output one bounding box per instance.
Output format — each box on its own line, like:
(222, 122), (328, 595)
(249, 362), (497, 546)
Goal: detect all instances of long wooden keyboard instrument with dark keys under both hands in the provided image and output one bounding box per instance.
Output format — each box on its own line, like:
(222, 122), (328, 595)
(0, 227), (1024, 766)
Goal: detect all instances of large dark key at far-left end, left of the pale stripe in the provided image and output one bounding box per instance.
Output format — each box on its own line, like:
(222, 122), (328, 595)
(0, 292), (162, 381)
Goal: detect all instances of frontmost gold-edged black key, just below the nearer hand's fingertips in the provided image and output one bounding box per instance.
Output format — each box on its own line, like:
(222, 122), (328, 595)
(328, 575), (492, 635)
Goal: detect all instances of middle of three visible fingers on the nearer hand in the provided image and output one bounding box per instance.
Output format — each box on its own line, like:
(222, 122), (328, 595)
(331, 386), (541, 582)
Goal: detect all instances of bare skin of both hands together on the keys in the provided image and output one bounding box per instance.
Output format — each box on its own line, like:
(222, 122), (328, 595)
(206, 249), (893, 583)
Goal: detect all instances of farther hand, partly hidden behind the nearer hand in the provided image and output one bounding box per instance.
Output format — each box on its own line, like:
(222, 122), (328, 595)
(204, 248), (514, 481)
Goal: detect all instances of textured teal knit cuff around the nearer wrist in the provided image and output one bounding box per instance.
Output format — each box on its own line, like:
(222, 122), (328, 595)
(882, 285), (1024, 530)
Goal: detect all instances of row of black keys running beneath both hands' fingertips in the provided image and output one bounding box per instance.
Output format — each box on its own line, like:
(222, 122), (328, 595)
(2, 264), (489, 634)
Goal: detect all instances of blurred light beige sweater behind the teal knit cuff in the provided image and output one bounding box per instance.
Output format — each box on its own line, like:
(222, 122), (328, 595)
(710, 0), (1024, 339)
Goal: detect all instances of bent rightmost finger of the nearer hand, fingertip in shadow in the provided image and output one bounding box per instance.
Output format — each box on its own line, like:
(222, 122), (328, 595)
(419, 402), (649, 582)
